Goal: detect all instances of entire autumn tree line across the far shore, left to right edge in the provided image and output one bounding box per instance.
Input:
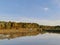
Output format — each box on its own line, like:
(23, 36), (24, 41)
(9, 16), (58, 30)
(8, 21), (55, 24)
(0, 21), (60, 30)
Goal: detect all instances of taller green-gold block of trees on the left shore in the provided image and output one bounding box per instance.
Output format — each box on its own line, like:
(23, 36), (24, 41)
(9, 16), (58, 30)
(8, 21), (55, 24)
(0, 21), (39, 29)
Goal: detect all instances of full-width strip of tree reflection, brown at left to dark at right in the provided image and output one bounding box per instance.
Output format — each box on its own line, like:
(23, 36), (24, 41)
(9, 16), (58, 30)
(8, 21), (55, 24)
(0, 31), (60, 40)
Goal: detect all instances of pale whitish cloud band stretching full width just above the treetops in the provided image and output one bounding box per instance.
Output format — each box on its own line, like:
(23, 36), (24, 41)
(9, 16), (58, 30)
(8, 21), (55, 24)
(0, 16), (60, 26)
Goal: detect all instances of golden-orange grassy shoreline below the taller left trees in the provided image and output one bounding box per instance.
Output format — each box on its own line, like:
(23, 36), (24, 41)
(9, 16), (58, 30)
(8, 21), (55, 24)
(0, 28), (38, 34)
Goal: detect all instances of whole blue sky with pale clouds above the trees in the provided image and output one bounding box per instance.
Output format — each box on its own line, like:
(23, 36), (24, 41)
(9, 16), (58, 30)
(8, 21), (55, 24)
(0, 0), (60, 25)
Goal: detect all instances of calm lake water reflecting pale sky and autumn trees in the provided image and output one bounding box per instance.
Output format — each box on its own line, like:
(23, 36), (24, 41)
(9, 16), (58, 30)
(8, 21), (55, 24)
(0, 33), (60, 45)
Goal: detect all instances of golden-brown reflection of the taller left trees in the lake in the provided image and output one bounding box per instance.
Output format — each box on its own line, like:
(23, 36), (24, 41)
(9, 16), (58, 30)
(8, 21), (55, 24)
(0, 32), (43, 39)
